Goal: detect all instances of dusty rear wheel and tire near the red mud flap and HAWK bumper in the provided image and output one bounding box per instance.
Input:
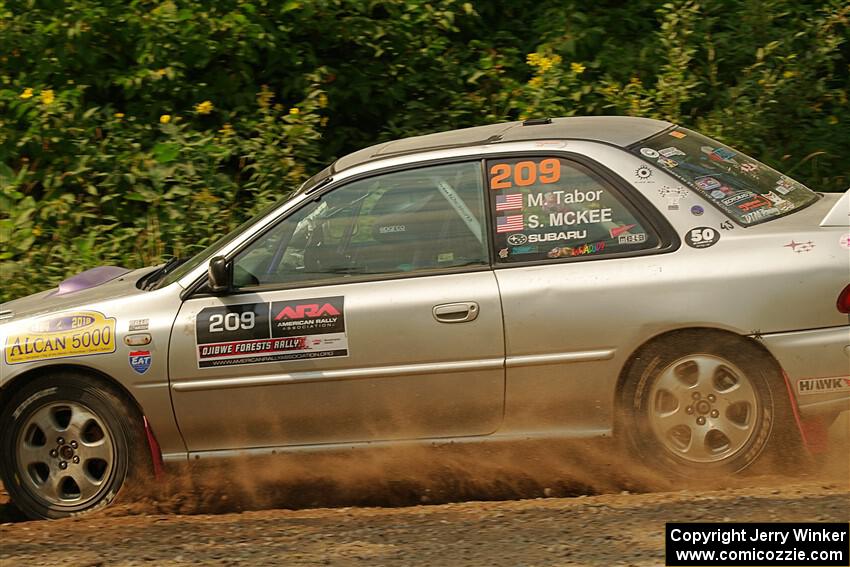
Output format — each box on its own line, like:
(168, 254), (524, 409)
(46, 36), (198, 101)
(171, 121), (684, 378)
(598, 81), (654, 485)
(620, 332), (793, 478)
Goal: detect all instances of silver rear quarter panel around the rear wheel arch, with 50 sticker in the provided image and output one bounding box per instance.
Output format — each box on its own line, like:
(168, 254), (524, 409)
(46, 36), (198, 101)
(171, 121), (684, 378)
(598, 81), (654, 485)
(496, 142), (850, 435)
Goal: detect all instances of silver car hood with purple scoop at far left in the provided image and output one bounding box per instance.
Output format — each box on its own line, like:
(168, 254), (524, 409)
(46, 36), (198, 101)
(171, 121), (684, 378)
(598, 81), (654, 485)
(0, 266), (156, 325)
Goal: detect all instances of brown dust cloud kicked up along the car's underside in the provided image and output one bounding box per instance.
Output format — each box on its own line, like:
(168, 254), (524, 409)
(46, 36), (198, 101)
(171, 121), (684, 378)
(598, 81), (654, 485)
(107, 412), (850, 516)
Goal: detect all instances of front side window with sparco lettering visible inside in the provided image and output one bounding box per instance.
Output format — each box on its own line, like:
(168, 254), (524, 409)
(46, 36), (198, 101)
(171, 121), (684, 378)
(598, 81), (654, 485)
(234, 162), (488, 288)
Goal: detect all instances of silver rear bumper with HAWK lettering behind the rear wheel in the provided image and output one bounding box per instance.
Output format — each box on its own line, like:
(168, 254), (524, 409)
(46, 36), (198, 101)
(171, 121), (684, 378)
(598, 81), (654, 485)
(761, 326), (850, 418)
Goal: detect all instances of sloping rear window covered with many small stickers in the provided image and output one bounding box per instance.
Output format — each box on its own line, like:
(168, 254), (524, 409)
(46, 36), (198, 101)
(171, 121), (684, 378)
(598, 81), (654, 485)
(631, 127), (817, 226)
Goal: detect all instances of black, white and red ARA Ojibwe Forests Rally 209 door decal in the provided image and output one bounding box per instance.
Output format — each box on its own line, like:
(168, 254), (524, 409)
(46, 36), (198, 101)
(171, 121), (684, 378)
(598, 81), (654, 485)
(195, 296), (348, 368)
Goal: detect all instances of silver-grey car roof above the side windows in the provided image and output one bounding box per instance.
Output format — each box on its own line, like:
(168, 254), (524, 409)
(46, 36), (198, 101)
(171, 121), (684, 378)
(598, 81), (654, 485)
(329, 116), (673, 173)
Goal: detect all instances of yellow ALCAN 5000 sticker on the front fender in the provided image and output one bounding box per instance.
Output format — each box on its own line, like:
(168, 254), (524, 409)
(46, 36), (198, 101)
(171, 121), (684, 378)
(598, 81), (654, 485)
(4, 311), (115, 364)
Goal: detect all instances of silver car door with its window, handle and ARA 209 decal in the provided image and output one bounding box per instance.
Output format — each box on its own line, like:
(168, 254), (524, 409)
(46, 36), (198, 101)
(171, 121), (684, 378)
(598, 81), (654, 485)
(169, 162), (504, 451)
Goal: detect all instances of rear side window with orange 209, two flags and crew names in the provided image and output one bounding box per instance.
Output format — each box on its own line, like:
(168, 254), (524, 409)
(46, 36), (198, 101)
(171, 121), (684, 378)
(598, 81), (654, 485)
(487, 157), (658, 264)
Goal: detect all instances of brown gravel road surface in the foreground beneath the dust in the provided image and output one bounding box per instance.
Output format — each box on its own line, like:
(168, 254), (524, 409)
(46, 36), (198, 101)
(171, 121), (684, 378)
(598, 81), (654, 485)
(0, 481), (850, 567)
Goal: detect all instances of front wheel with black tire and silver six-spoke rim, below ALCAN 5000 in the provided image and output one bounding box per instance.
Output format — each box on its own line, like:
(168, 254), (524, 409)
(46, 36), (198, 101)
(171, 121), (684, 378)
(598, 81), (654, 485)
(0, 370), (149, 519)
